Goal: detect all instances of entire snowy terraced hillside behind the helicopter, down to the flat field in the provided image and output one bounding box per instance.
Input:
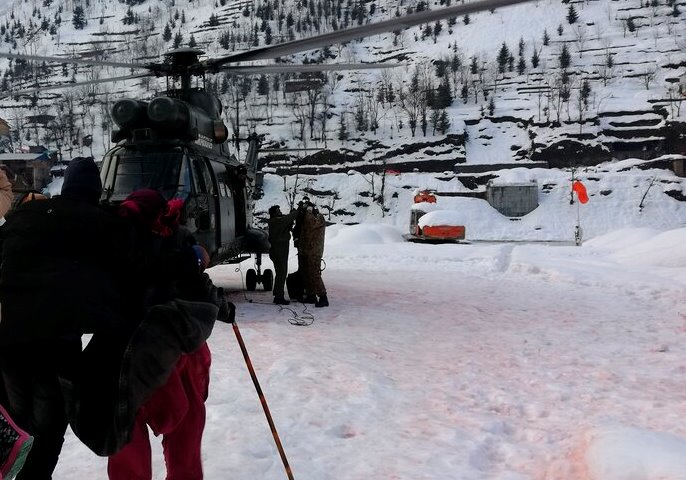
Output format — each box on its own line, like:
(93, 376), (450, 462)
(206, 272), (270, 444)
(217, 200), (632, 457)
(0, 0), (686, 235)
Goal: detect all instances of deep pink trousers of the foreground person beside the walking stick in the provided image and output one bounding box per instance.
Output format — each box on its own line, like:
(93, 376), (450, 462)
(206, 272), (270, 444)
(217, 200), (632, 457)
(107, 343), (211, 480)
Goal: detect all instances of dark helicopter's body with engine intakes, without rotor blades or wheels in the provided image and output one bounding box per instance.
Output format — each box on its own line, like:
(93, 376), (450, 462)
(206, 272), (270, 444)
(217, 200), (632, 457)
(101, 92), (269, 265)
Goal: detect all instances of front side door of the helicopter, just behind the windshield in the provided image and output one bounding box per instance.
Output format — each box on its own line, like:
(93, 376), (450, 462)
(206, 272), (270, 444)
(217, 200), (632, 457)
(191, 158), (219, 252)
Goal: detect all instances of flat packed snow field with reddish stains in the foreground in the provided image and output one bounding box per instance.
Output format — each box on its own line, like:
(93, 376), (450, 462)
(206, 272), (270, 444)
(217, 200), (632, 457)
(54, 224), (686, 480)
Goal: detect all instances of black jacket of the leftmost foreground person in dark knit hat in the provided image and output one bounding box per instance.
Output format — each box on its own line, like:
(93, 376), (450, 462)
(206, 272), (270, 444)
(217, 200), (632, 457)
(0, 196), (135, 346)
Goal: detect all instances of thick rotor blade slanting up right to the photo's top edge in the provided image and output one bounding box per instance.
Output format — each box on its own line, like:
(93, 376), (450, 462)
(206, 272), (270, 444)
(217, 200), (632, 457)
(201, 0), (532, 71)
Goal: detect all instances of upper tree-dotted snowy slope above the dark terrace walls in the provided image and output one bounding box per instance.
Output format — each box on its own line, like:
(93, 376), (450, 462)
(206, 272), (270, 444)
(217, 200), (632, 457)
(0, 0), (686, 164)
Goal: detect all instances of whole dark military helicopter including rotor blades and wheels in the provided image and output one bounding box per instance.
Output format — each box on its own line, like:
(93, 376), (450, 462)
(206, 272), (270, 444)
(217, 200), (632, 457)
(0, 0), (531, 290)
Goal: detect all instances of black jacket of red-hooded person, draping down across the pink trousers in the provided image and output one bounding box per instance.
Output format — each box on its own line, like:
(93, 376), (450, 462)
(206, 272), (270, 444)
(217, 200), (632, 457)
(63, 223), (228, 456)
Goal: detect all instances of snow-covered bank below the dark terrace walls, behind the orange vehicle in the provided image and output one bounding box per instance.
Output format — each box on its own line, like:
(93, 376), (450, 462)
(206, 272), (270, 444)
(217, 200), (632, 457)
(256, 160), (686, 242)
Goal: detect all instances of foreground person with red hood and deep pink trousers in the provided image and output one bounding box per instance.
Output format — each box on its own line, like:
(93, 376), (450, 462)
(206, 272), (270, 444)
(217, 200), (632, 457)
(107, 189), (231, 480)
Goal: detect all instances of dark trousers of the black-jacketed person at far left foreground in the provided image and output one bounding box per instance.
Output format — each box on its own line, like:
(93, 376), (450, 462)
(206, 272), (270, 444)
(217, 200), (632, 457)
(0, 338), (81, 480)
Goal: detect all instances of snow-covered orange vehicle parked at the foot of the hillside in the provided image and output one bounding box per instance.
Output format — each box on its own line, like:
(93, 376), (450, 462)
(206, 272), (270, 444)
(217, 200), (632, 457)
(405, 190), (466, 243)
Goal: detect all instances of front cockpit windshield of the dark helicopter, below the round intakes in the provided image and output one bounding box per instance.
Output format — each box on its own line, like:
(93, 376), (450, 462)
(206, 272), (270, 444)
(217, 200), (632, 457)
(103, 148), (190, 201)
